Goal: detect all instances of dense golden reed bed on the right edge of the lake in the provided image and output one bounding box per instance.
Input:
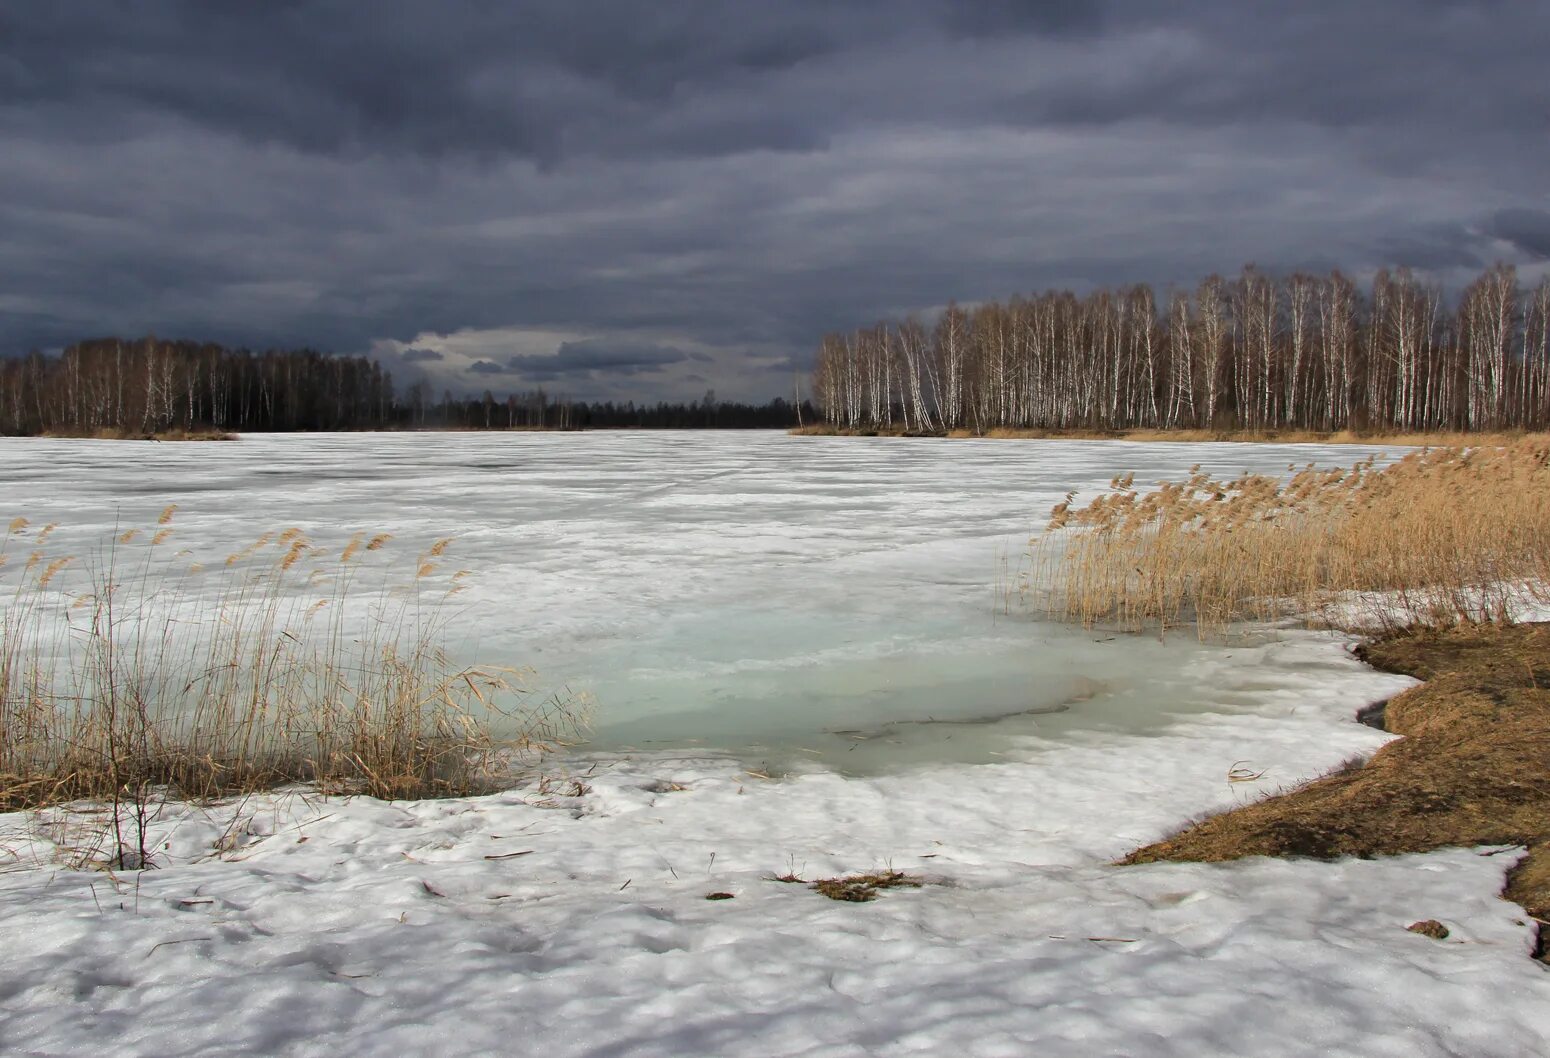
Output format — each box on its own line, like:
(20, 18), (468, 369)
(1025, 438), (1550, 635)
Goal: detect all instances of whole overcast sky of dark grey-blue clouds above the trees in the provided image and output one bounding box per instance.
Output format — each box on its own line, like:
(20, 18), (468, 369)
(0, 0), (1550, 400)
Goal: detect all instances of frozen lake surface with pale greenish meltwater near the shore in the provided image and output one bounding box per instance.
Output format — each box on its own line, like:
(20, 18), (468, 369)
(0, 432), (1407, 771)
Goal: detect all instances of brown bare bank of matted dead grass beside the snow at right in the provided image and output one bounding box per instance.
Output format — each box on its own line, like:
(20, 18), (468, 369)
(1121, 624), (1550, 957)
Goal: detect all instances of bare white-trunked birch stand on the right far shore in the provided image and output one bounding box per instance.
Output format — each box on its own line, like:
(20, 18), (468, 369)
(814, 265), (1550, 432)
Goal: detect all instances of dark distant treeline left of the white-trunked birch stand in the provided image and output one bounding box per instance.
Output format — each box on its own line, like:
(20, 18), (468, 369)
(0, 338), (817, 435)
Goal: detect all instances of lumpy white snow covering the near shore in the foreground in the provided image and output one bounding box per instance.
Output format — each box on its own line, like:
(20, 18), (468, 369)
(0, 616), (1550, 1058)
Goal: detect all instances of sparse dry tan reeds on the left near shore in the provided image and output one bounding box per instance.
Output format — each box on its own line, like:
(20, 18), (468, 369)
(0, 508), (581, 809)
